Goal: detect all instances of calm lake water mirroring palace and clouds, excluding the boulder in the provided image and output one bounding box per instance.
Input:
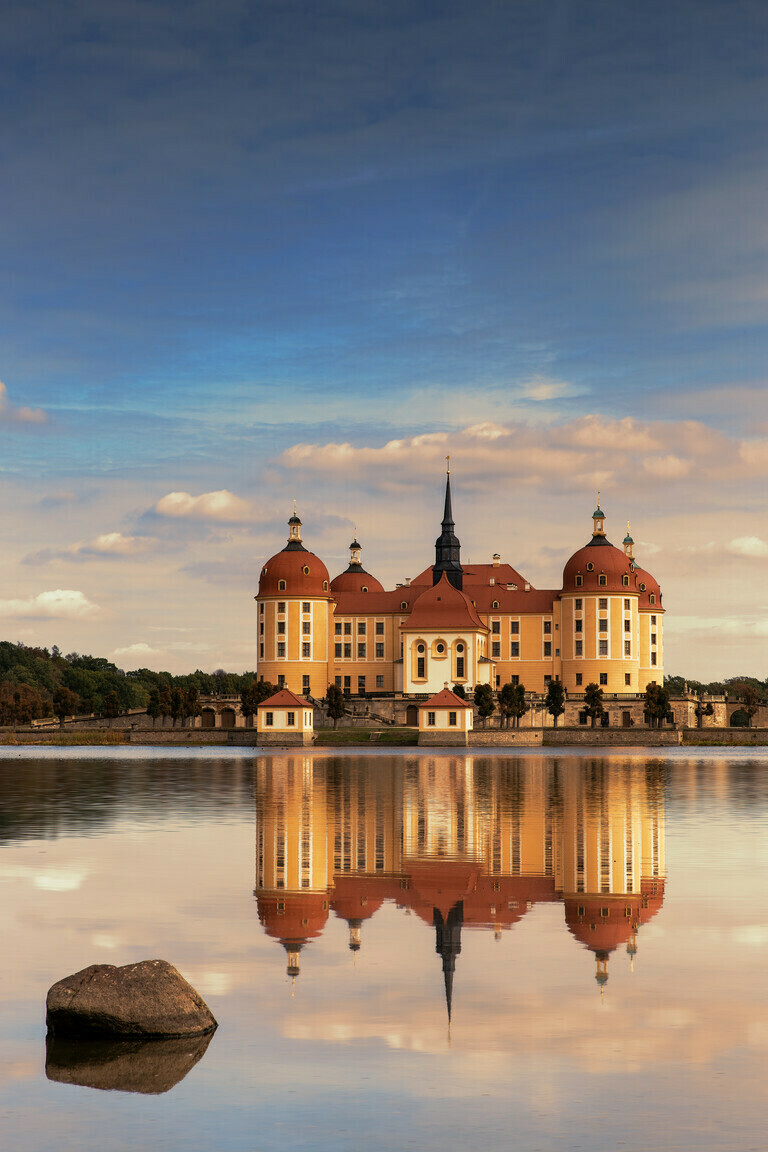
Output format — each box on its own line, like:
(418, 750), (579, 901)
(0, 749), (768, 1152)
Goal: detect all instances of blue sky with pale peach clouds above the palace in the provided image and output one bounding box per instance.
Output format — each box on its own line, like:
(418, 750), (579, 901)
(0, 0), (768, 680)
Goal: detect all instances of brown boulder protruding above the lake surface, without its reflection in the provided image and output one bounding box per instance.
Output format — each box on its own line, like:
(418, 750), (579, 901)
(46, 960), (216, 1038)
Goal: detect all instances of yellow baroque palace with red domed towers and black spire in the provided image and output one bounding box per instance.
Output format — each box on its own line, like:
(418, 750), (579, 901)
(256, 472), (663, 697)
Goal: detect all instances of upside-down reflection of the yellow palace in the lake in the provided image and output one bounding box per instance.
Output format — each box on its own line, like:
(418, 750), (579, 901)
(254, 755), (664, 1015)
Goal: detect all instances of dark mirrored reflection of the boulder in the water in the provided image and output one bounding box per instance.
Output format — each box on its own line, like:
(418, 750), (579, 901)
(45, 1032), (213, 1096)
